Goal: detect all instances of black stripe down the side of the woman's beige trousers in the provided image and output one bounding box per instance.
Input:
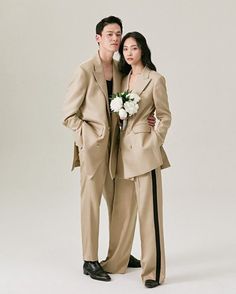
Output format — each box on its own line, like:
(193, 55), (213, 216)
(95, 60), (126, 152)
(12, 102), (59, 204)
(152, 170), (161, 282)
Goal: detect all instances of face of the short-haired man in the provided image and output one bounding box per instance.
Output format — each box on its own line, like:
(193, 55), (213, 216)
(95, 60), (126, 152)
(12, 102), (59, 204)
(96, 23), (121, 53)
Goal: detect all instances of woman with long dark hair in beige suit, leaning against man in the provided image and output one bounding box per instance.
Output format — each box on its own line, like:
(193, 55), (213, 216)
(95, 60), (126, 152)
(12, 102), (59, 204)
(103, 32), (171, 288)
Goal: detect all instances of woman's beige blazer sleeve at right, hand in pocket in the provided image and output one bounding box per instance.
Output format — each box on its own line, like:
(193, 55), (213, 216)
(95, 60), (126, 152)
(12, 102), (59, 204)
(153, 76), (171, 145)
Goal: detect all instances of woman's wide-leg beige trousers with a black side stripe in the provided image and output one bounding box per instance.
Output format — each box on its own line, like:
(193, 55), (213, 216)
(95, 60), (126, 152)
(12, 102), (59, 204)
(102, 168), (165, 284)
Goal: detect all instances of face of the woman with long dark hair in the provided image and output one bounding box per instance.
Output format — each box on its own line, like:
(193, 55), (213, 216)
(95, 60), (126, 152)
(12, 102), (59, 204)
(123, 37), (142, 66)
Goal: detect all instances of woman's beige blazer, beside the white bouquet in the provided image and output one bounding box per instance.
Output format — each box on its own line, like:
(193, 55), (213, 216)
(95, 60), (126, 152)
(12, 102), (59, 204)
(117, 67), (171, 179)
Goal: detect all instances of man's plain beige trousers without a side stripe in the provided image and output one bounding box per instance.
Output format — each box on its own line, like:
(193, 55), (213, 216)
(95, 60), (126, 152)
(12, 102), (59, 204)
(80, 153), (114, 261)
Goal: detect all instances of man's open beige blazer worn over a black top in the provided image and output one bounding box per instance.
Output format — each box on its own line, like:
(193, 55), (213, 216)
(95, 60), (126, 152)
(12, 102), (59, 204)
(63, 53), (121, 177)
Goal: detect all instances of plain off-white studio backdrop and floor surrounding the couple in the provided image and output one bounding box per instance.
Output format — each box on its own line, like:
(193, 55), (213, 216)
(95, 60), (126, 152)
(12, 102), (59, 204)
(0, 0), (236, 294)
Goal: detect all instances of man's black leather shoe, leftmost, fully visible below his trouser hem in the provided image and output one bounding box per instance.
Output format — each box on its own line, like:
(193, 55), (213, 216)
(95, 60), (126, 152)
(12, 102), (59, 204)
(83, 261), (111, 282)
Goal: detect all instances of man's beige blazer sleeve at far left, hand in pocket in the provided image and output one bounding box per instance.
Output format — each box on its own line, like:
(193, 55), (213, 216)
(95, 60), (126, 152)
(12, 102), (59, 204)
(63, 67), (88, 131)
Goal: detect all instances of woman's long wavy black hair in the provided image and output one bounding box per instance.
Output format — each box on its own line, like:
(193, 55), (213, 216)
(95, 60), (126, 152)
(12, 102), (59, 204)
(118, 32), (156, 75)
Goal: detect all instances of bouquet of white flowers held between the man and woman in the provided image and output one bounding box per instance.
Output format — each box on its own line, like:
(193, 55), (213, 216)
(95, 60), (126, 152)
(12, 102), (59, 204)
(110, 91), (140, 130)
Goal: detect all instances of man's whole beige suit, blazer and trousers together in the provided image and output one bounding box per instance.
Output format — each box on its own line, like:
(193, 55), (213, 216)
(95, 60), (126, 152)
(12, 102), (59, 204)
(63, 54), (121, 261)
